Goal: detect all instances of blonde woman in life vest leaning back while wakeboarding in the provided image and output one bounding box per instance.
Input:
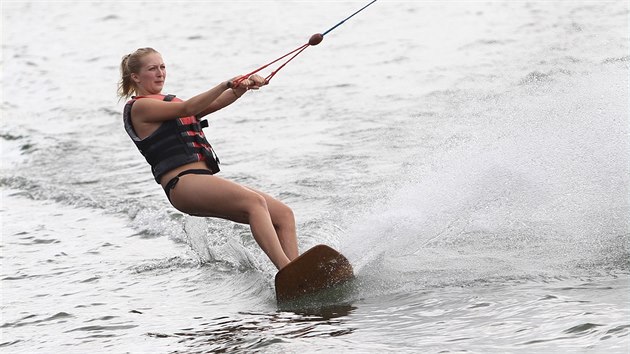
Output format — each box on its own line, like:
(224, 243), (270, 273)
(118, 48), (298, 269)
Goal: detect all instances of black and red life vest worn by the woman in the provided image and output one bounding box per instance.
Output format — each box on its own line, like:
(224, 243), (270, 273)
(123, 95), (220, 183)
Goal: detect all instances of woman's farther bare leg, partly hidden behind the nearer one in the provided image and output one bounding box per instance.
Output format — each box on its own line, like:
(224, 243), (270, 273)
(249, 188), (299, 260)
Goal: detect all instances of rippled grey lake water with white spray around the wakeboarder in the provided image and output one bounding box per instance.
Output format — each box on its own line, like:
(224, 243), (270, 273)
(0, 0), (630, 353)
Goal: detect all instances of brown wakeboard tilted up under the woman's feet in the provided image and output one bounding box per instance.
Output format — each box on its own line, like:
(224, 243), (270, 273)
(276, 245), (354, 302)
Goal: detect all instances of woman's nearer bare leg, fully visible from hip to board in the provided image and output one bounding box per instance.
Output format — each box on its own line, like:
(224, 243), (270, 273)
(170, 175), (290, 269)
